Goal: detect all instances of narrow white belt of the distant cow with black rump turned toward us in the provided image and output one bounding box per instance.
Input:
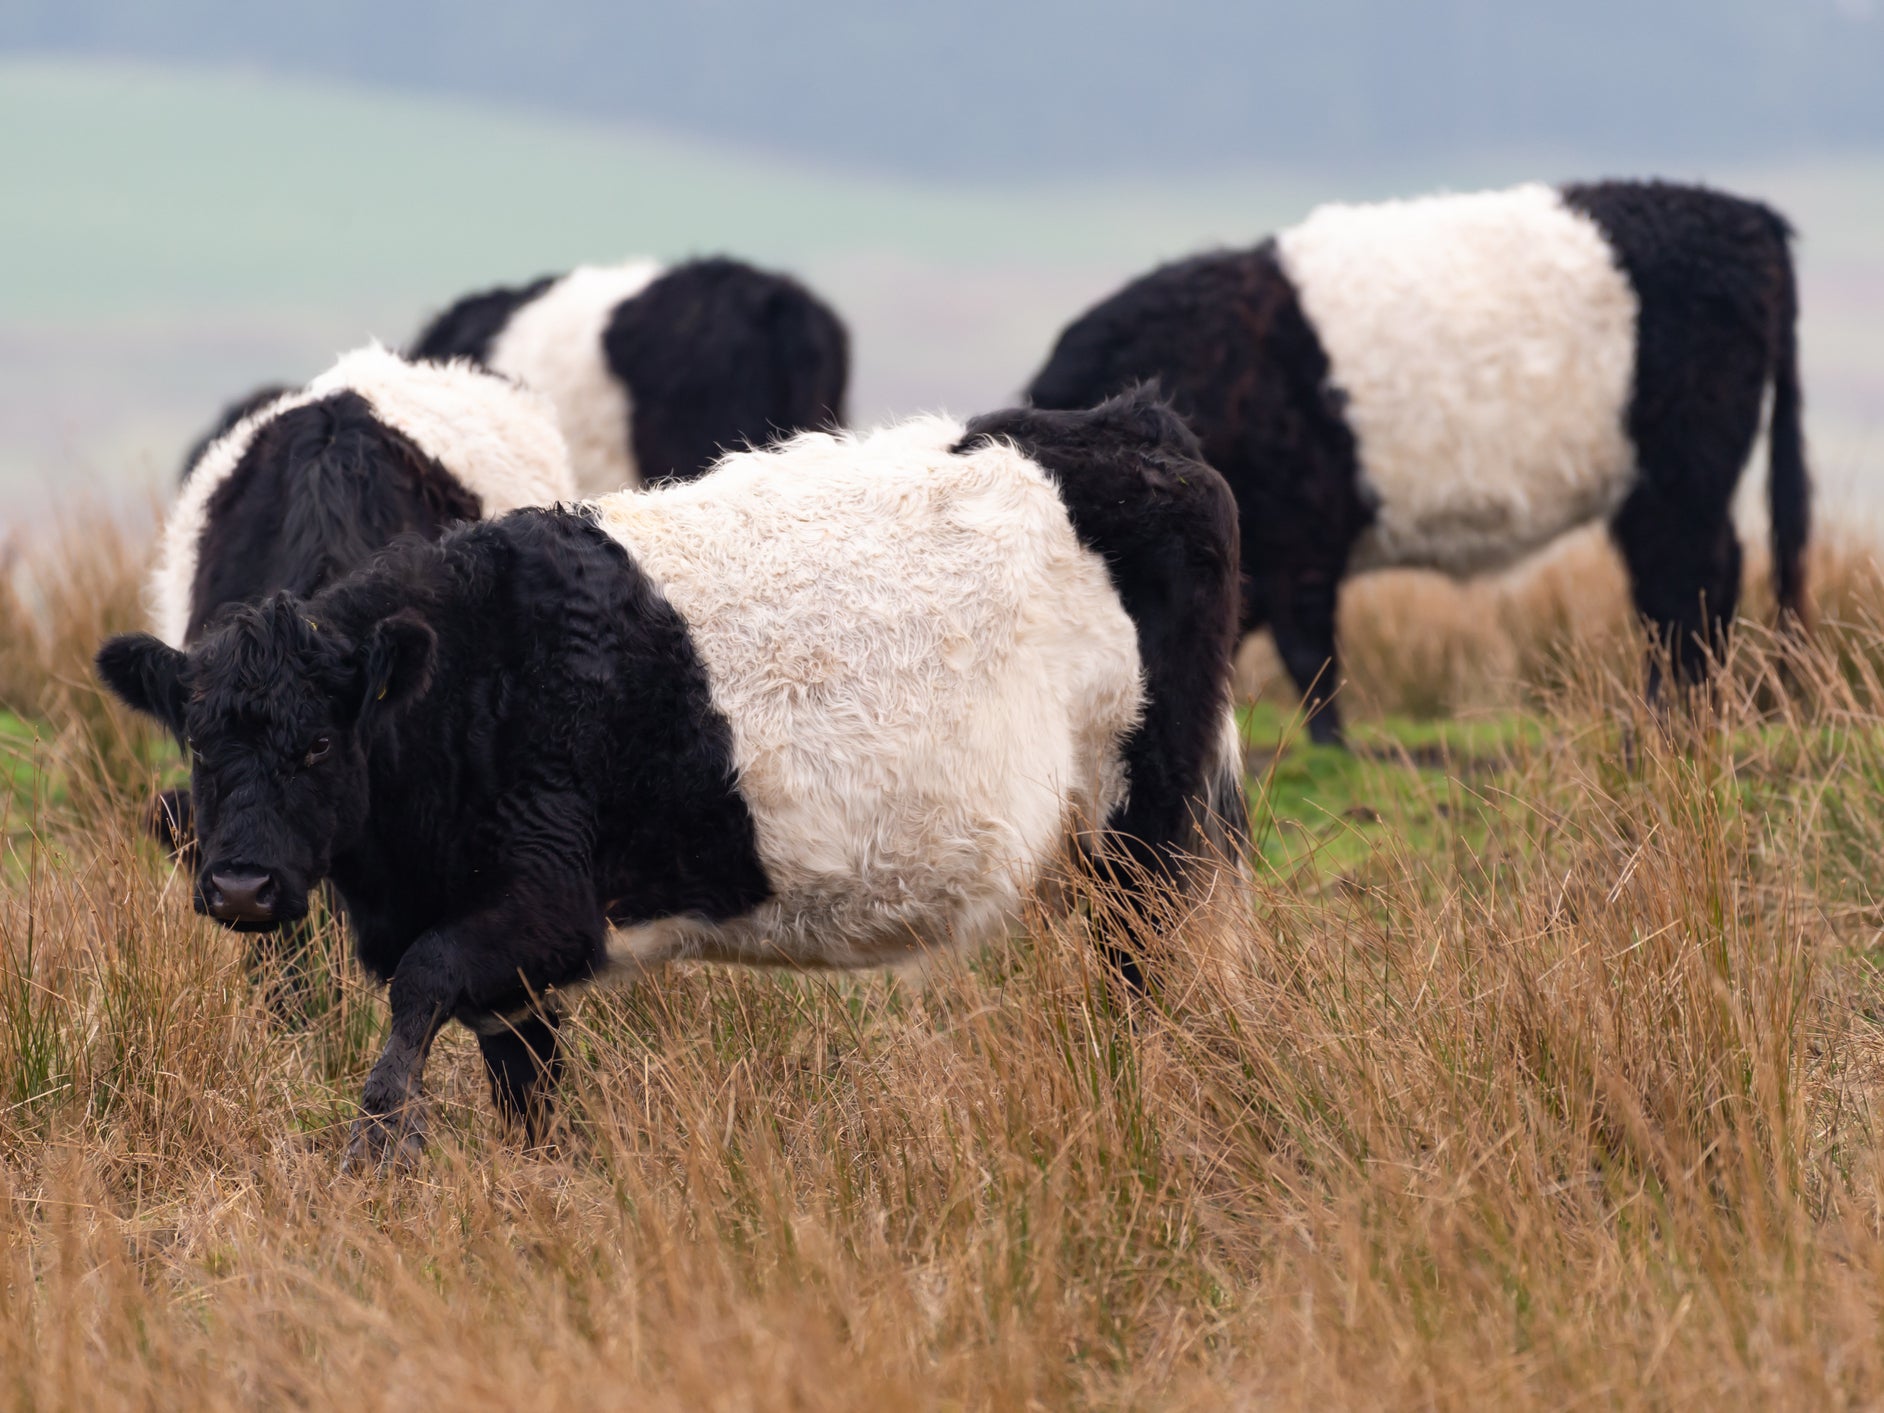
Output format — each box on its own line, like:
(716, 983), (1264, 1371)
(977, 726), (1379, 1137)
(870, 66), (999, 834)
(486, 260), (661, 495)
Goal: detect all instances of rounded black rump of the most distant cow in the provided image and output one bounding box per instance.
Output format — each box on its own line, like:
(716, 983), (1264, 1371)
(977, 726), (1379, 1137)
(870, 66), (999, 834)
(603, 258), (850, 484)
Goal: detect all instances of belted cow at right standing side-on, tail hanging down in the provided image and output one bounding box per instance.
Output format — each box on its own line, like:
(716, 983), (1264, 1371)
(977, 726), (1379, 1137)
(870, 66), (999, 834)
(1029, 181), (1809, 740)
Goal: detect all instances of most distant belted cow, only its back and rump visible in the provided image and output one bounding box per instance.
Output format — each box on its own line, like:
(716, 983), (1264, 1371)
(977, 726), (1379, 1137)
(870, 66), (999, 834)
(411, 260), (850, 495)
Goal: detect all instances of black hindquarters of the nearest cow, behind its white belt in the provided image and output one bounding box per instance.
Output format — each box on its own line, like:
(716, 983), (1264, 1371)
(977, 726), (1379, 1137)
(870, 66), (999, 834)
(955, 390), (1238, 896)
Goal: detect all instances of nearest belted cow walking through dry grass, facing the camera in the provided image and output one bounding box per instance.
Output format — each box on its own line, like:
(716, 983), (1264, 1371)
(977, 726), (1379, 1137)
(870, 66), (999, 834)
(98, 396), (1247, 1161)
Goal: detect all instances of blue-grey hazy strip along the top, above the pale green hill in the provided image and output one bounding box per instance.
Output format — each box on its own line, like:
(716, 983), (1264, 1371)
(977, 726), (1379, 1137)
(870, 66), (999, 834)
(0, 0), (1884, 179)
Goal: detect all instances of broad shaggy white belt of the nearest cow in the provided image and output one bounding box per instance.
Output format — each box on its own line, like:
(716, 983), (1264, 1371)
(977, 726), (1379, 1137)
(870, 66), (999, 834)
(595, 418), (1144, 966)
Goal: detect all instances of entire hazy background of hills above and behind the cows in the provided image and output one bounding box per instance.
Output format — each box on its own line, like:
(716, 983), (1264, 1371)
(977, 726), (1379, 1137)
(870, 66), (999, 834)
(0, 0), (1884, 524)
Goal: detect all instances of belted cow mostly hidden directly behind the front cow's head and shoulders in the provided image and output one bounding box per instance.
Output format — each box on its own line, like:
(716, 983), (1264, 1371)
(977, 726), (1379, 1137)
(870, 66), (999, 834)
(151, 347), (575, 846)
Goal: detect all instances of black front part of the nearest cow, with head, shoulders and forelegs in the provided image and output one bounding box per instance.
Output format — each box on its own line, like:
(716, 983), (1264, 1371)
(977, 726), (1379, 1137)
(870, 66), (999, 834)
(98, 511), (769, 1159)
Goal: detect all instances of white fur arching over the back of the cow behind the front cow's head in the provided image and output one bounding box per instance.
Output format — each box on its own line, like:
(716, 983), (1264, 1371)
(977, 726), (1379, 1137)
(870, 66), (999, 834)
(149, 343), (575, 648)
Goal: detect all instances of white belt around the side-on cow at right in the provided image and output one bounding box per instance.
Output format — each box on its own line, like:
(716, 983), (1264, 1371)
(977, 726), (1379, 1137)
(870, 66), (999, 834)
(1277, 185), (1637, 575)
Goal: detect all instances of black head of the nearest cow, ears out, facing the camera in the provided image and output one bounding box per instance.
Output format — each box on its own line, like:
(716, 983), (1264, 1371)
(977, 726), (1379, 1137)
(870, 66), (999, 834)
(98, 593), (437, 933)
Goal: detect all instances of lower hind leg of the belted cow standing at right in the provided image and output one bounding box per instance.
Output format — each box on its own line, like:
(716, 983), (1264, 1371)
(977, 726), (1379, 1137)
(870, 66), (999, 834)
(1613, 486), (1741, 703)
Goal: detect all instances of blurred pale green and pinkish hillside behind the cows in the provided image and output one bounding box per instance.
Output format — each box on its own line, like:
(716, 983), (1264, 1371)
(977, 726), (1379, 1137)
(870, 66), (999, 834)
(0, 60), (1884, 518)
